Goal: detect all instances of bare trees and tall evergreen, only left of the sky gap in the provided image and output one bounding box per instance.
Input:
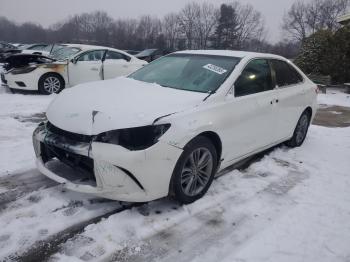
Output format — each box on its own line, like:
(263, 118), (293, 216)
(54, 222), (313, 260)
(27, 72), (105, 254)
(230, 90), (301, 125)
(0, 1), (293, 56)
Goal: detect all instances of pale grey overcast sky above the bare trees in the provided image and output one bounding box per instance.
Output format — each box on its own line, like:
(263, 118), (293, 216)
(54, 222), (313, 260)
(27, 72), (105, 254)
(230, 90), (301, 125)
(0, 0), (300, 42)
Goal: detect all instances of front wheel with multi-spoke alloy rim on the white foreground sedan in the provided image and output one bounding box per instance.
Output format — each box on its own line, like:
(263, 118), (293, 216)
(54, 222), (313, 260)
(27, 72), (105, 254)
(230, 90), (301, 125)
(170, 136), (218, 204)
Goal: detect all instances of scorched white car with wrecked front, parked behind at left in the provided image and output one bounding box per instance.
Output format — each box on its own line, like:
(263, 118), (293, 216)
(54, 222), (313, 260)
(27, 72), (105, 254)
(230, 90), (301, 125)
(1, 44), (147, 94)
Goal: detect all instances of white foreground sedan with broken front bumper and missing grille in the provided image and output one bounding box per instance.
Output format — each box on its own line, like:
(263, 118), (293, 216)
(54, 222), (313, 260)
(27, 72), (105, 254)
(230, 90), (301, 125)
(33, 51), (317, 203)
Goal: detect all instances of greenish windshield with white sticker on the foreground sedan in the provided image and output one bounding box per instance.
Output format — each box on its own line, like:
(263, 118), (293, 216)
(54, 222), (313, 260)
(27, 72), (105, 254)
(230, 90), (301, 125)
(129, 54), (240, 93)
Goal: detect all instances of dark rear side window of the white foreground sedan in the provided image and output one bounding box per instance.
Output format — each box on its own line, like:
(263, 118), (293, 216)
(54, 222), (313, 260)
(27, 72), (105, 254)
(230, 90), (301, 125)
(271, 60), (303, 87)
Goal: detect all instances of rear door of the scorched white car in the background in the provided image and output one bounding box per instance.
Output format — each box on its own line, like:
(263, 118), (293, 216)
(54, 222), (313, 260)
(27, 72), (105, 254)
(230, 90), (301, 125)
(103, 50), (134, 79)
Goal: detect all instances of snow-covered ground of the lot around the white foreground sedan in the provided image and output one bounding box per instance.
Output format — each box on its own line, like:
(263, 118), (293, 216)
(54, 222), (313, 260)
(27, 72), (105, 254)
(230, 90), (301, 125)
(0, 85), (350, 262)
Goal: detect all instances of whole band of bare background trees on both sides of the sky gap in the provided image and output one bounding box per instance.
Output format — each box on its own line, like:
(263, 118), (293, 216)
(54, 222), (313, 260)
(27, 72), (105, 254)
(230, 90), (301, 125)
(0, 0), (350, 62)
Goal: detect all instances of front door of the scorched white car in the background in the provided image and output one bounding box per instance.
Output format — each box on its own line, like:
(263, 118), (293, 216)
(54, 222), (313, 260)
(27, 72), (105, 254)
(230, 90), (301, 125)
(68, 50), (105, 86)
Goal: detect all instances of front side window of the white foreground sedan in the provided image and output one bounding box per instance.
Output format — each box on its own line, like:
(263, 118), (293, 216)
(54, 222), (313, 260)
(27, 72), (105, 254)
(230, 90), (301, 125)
(235, 59), (273, 97)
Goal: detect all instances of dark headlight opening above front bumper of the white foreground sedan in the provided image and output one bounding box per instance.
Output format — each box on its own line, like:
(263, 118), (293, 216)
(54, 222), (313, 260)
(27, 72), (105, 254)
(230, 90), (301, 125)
(94, 124), (170, 150)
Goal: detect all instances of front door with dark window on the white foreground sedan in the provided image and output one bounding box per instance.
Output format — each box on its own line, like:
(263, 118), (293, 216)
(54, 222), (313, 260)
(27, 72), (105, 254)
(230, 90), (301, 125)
(225, 59), (278, 160)
